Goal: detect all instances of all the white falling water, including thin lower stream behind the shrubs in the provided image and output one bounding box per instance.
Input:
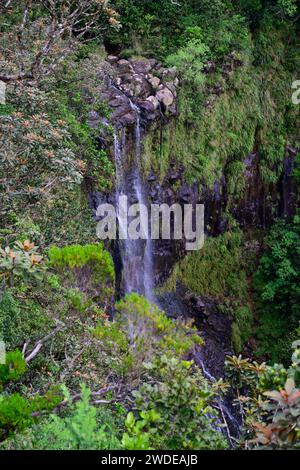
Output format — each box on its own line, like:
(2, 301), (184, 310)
(110, 87), (240, 447)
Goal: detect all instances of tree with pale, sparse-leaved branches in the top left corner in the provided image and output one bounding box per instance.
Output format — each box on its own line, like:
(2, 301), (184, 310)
(0, 0), (120, 83)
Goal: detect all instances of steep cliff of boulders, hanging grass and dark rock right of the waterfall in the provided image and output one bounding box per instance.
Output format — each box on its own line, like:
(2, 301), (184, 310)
(91, 23), (300, 369)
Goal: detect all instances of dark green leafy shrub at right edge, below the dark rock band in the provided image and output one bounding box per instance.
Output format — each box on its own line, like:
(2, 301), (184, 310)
(254, 216), (300, 363)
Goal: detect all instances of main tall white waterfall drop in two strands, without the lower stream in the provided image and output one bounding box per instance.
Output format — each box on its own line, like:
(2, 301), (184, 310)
(114, 101), (155, 302)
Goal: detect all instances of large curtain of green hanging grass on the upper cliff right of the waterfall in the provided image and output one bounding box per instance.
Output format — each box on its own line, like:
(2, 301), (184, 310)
(143, 23), (299, 196)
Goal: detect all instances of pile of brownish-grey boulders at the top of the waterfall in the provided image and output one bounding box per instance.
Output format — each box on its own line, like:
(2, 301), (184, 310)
(91, 55), (179, 129)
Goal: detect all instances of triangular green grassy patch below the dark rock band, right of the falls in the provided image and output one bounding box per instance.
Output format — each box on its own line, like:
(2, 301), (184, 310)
(161, 230), (253, 353)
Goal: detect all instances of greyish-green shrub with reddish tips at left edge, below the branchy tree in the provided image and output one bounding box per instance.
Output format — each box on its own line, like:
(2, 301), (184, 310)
(0, 99), (82, 213)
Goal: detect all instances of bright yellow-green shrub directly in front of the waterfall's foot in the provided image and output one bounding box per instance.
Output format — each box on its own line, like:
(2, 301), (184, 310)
(93, 293), (202, 379)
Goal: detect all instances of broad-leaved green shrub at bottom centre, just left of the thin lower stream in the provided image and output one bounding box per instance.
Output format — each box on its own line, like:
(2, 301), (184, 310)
(133, 355), (226, 449)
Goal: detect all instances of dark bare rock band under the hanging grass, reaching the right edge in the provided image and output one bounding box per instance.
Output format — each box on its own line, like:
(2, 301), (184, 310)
(201, 143), (299, 235)
